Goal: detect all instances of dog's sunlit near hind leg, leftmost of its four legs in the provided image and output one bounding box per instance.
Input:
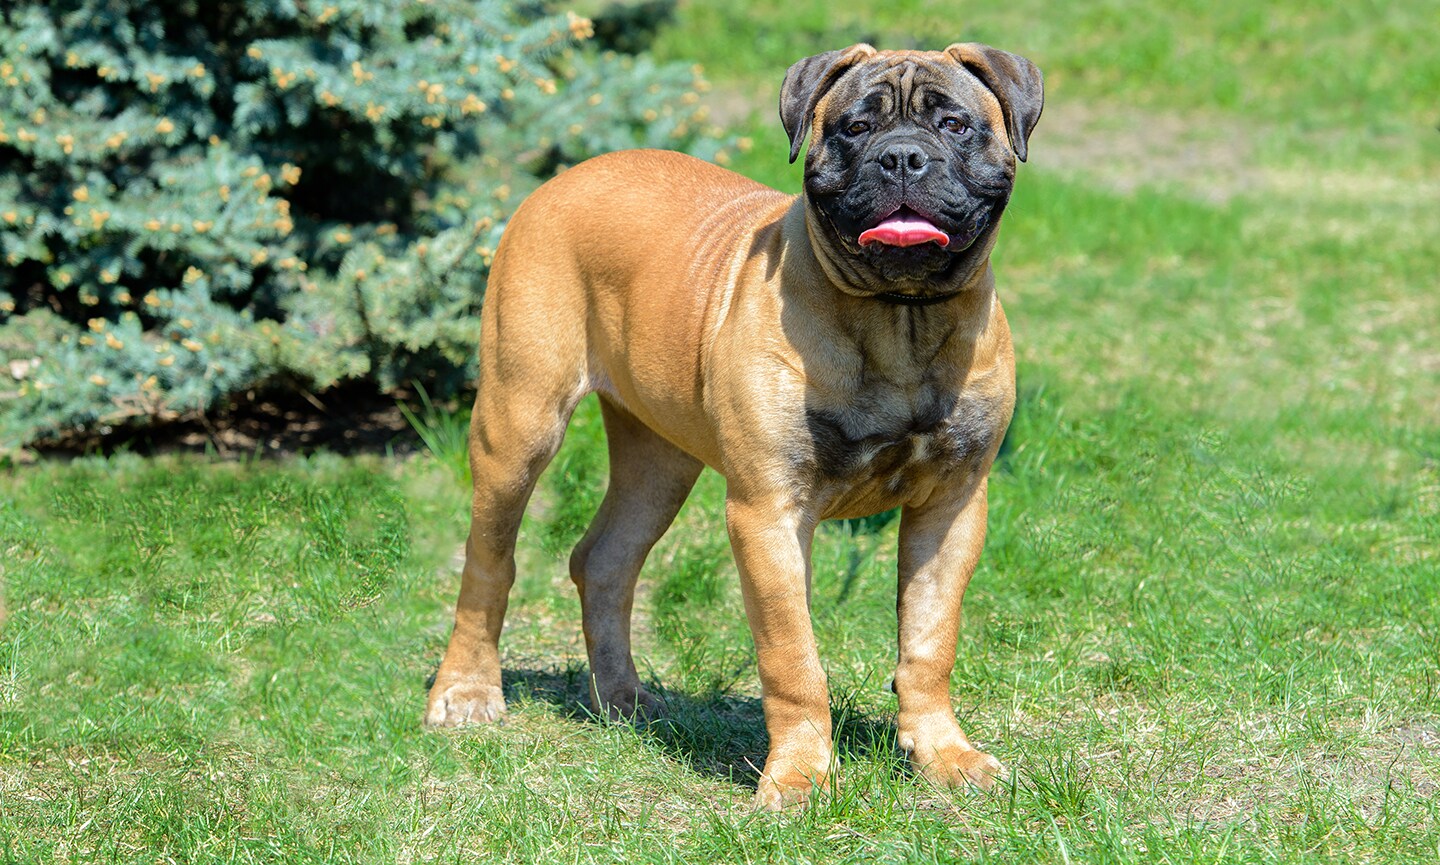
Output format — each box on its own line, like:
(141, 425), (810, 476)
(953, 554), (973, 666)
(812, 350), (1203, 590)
(425, 286), (590, 727)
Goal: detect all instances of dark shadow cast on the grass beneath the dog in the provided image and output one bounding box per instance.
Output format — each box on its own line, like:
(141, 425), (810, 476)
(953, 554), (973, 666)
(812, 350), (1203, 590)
(489, 665), (904, 790)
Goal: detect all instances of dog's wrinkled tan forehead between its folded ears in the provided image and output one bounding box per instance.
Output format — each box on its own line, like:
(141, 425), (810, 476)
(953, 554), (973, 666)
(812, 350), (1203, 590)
(827, 50), (1005, 130)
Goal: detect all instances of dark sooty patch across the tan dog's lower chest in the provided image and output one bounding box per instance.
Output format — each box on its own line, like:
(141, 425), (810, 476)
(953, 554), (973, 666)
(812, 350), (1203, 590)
(805, 383), (1009, 494)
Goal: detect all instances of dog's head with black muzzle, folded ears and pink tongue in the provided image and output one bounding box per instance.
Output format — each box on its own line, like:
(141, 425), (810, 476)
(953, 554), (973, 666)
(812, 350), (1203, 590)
(780, 43), (1044, 298)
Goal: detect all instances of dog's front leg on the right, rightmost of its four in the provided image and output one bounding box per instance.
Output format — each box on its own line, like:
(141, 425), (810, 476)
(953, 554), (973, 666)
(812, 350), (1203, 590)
(894, 479), (1005, 789)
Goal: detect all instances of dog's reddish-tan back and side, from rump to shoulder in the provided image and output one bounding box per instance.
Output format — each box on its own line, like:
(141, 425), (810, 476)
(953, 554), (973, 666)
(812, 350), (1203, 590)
(481, 150), (795, 466)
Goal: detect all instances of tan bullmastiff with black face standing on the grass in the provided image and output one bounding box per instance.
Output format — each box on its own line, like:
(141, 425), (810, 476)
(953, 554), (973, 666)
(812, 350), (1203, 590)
(425, 43), (1043, 809)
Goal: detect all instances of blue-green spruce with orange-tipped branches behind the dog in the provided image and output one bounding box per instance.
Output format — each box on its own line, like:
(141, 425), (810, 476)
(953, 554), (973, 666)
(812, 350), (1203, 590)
(0, 0), (727, 453)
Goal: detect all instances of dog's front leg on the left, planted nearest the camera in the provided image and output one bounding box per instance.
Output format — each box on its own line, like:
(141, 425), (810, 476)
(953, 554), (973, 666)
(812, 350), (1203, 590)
(726, 494), (832, 810)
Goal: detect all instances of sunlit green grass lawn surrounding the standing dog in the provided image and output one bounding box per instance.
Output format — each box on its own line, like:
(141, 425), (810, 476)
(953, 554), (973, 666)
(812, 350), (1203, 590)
(0, 0), (1440, 864)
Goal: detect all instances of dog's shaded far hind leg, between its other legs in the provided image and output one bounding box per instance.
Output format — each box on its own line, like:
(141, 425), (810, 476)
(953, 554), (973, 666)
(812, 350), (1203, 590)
(570, 397), (703, 720)
